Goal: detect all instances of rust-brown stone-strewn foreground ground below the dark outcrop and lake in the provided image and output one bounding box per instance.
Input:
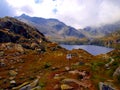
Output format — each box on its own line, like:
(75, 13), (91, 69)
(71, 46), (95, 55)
(0, 43), (120, 90)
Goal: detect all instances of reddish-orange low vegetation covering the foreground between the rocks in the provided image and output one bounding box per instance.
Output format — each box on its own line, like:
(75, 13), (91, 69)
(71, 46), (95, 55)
(0, 44), (119, 90)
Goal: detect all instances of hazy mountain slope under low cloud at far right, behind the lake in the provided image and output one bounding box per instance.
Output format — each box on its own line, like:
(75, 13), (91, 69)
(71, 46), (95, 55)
(79, 21), (120, 39)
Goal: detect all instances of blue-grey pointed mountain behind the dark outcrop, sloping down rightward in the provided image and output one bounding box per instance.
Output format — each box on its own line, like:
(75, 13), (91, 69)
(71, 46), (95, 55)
(15, 14), (85, 42)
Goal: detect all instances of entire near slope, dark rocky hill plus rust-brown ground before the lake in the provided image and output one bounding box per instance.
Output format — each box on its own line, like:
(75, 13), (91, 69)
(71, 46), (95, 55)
(0, 17), (120, 90)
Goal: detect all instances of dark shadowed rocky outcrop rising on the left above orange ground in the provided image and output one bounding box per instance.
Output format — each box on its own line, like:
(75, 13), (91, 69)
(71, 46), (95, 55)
(0, 17), (48, 51)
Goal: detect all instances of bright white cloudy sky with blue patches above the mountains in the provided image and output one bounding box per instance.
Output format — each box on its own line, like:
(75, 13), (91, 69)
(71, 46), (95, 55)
(0, 0), (120, 28)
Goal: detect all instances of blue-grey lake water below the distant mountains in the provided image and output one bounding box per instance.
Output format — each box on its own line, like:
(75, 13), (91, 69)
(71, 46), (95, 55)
(61, 45), (113, 55)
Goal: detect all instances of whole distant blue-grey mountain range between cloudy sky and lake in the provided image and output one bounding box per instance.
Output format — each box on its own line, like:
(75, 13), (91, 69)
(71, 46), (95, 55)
(15, 14), (120, 44)
